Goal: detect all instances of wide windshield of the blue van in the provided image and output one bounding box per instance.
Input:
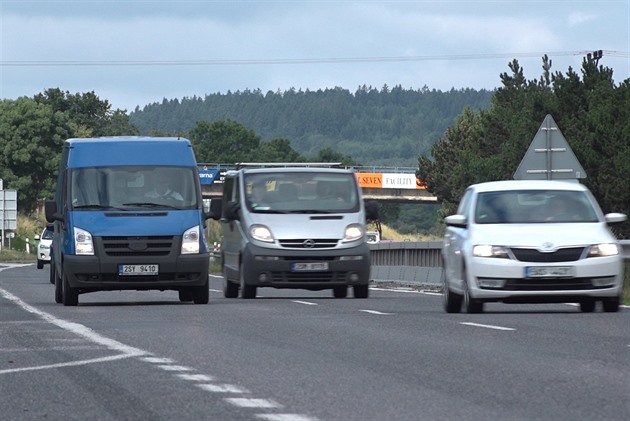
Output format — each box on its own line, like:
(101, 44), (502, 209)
(69, 166), (198, 210)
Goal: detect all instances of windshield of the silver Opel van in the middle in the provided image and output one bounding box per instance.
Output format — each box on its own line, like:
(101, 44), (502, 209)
(244, 172), (360, 213)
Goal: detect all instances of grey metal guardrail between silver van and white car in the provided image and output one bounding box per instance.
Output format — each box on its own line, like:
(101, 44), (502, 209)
(370, 240), (630, 286)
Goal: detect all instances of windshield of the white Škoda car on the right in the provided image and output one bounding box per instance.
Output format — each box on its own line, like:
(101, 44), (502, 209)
(474, 190), (599, 224)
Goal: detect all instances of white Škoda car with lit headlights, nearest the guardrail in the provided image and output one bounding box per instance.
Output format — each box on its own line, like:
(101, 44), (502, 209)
(442, 180), (626, 313)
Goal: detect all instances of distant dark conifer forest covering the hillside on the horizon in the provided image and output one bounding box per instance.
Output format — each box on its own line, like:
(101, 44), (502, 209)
(129, 86), (493, 167)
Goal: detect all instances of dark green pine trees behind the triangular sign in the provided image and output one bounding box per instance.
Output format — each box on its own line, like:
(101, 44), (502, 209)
(416, 56), (630, 237)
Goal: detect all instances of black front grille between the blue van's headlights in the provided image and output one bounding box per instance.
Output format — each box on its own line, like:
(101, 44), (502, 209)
(96, 236), (175, 257)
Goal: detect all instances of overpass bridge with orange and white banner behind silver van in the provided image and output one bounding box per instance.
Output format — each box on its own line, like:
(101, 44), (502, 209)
(199, 163), (437, 203)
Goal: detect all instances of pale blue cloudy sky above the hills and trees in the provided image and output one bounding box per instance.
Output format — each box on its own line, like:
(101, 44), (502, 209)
(0, 0), (630, 112)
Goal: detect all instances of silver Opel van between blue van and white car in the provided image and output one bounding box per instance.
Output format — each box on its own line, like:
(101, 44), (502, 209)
(211, 163), (376, 298)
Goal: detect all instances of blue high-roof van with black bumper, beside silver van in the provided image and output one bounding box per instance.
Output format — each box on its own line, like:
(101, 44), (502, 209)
(45, 137), (215, 306)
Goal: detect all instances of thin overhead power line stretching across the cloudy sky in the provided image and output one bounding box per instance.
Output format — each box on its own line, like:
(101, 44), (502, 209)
(0, 50), (630, 67)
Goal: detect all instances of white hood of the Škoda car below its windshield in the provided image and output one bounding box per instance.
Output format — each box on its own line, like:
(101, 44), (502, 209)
(470, 222), (616, 249)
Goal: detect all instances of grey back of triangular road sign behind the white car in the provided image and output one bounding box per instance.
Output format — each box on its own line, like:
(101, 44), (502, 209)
(514, 114), (586, 180)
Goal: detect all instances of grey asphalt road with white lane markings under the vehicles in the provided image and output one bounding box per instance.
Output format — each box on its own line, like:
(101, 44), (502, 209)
(0, 264), (630, 421)
